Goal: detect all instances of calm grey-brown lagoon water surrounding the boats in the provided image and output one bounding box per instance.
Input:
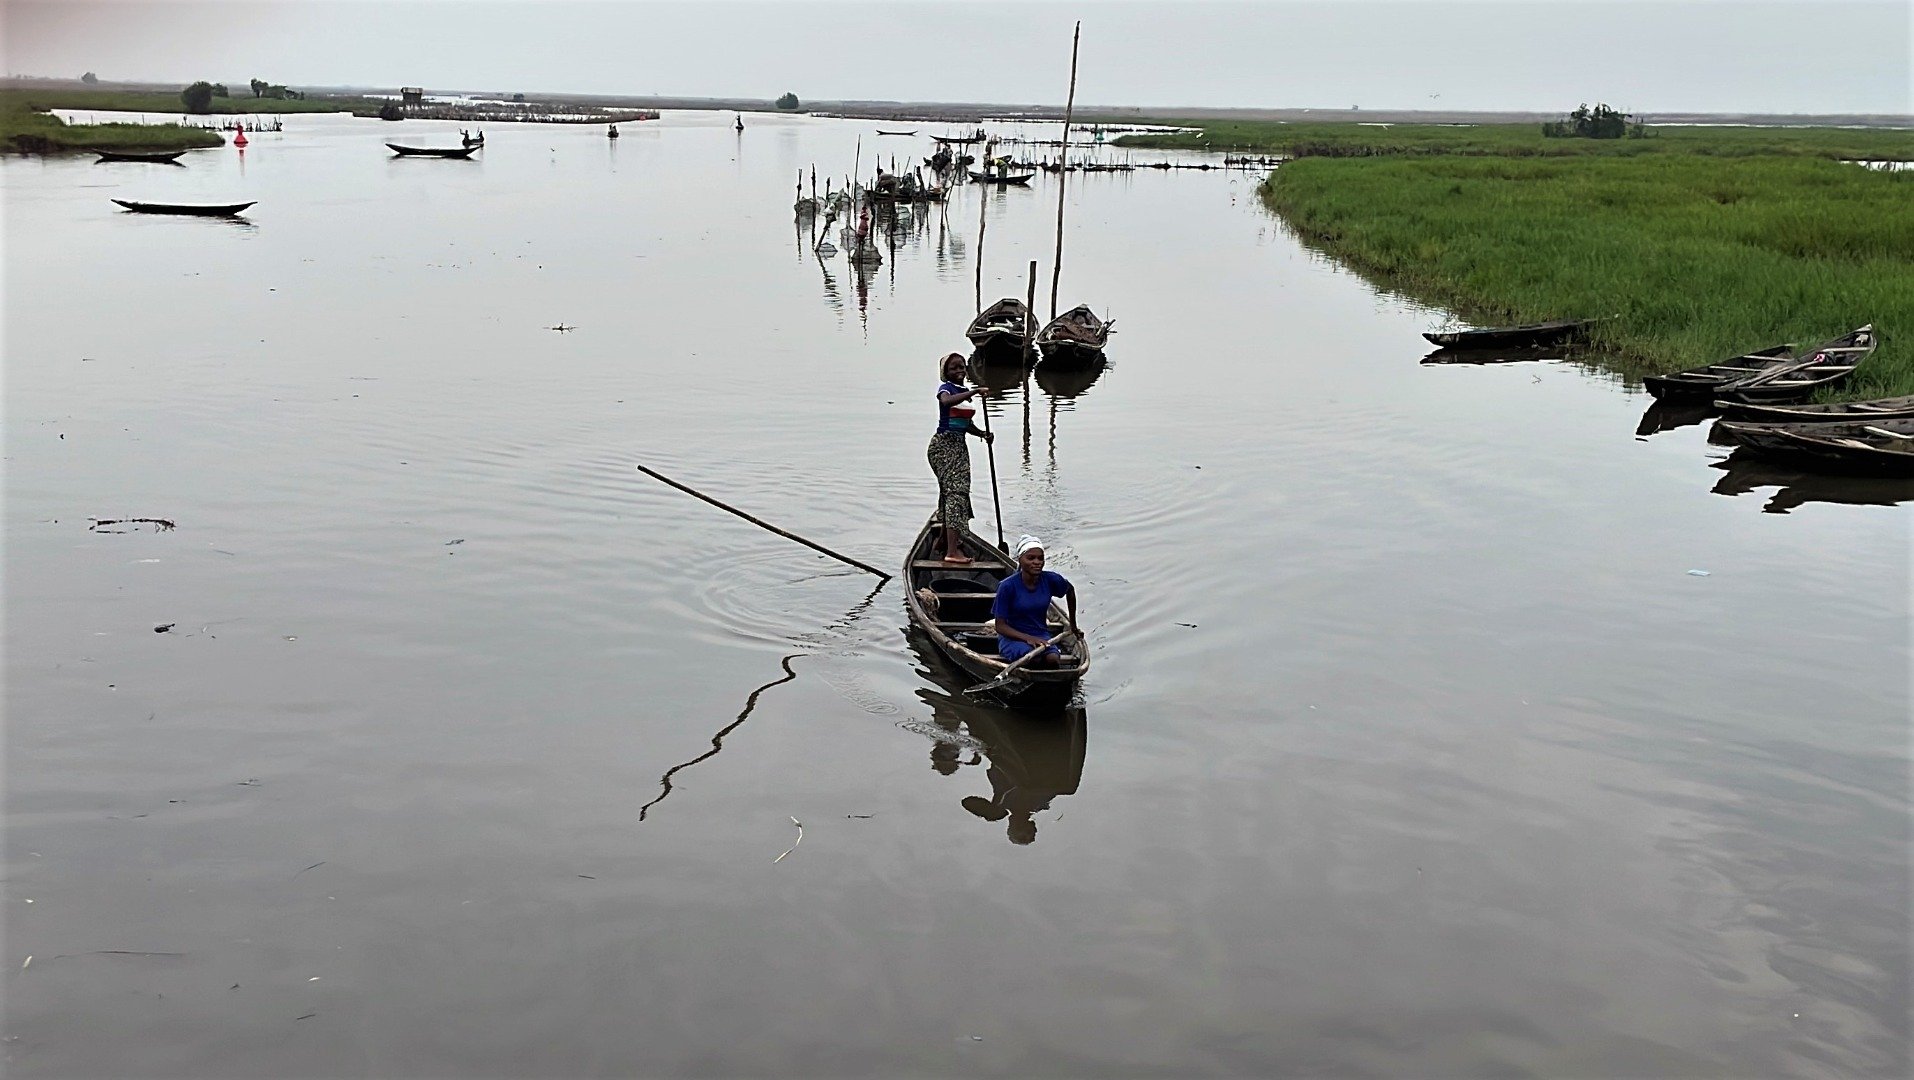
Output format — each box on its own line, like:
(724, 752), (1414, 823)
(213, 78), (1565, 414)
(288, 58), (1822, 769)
(0, 115), (1910, 1076)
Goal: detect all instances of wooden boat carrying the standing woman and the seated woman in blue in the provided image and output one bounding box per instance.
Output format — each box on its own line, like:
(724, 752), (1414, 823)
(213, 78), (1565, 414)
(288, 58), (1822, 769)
(903, 519), (1089, 701)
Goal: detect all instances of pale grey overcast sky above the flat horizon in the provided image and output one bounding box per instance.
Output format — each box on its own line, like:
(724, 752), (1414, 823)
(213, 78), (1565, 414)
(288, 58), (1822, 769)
(0, 0), (1914, 113)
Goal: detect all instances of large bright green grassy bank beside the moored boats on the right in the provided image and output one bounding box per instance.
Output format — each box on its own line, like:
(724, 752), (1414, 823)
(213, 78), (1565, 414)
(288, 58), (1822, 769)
(1125, 123), (1914, 398)
